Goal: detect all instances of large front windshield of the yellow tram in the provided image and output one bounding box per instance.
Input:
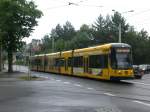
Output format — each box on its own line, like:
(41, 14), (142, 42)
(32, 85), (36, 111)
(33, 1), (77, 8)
(111, 48), (132, 69)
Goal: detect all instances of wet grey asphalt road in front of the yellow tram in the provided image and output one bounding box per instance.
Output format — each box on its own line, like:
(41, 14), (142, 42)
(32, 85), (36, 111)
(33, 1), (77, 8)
(0, 66), (150, 112)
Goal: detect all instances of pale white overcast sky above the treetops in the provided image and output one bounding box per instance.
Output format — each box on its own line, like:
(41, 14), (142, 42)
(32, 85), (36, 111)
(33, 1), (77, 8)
(25, 0), (150, 43)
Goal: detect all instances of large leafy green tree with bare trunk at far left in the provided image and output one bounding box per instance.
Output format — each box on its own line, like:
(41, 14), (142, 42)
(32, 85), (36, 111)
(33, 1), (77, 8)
(0, 0), (42, 72)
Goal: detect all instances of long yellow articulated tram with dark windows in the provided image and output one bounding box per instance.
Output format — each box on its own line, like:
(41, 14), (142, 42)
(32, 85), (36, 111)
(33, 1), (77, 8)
(30, 43), (134, 80)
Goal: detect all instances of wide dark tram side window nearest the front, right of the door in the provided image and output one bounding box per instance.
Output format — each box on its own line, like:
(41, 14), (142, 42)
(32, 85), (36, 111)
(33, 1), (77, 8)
(89, 55), (108, 68)
